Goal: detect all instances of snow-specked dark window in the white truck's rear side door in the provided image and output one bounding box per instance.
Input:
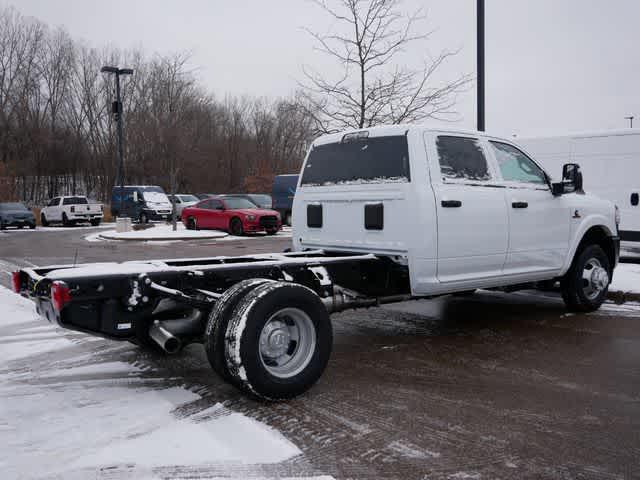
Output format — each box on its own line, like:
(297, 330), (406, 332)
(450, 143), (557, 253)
(436, 136), (491, 181)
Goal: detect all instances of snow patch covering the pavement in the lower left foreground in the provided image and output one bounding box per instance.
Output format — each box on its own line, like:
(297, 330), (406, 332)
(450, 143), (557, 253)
(0, 287), (329, 480)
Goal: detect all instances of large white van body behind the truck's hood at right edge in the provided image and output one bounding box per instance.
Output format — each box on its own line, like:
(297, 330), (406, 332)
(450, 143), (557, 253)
(516, 129), (640, 242)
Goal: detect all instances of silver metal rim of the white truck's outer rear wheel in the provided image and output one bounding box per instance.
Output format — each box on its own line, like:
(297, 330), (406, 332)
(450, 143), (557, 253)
(259, 308), (316, 378)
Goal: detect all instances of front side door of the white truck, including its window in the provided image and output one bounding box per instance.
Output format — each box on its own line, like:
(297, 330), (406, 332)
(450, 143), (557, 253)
(488, 140), (573, 279)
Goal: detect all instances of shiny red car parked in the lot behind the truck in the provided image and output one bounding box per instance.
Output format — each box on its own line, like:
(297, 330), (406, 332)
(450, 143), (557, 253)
(182, 196), (282, 236)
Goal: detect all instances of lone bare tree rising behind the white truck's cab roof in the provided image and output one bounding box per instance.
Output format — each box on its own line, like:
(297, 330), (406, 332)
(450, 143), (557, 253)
(301, 0), (472, 132)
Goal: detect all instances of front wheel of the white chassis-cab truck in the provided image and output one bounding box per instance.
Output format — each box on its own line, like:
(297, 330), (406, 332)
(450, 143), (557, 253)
(560, 245), (611, 312)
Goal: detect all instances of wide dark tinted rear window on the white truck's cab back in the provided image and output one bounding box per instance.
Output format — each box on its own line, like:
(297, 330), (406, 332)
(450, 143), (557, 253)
(301, 135), (410, 186)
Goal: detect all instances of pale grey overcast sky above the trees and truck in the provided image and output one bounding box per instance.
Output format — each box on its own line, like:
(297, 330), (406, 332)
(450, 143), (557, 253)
(5, 0), (640, 136)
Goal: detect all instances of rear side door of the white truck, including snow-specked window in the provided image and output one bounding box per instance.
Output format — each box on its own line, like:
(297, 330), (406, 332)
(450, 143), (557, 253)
(426, 134), (509, 291)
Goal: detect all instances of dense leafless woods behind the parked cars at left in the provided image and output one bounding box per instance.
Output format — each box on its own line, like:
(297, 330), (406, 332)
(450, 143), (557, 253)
(0, 7), (314, 205)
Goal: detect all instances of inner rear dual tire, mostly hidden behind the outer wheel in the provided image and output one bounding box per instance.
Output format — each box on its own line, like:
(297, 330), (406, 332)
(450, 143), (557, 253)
(204, 278), (272, 387)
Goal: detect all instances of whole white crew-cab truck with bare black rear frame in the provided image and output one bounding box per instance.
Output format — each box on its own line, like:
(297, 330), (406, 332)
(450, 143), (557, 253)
(13, 125), (619, 400)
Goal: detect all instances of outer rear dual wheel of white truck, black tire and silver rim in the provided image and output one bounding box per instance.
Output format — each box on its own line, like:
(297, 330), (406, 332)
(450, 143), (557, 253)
(225, 282), (333, 401)
